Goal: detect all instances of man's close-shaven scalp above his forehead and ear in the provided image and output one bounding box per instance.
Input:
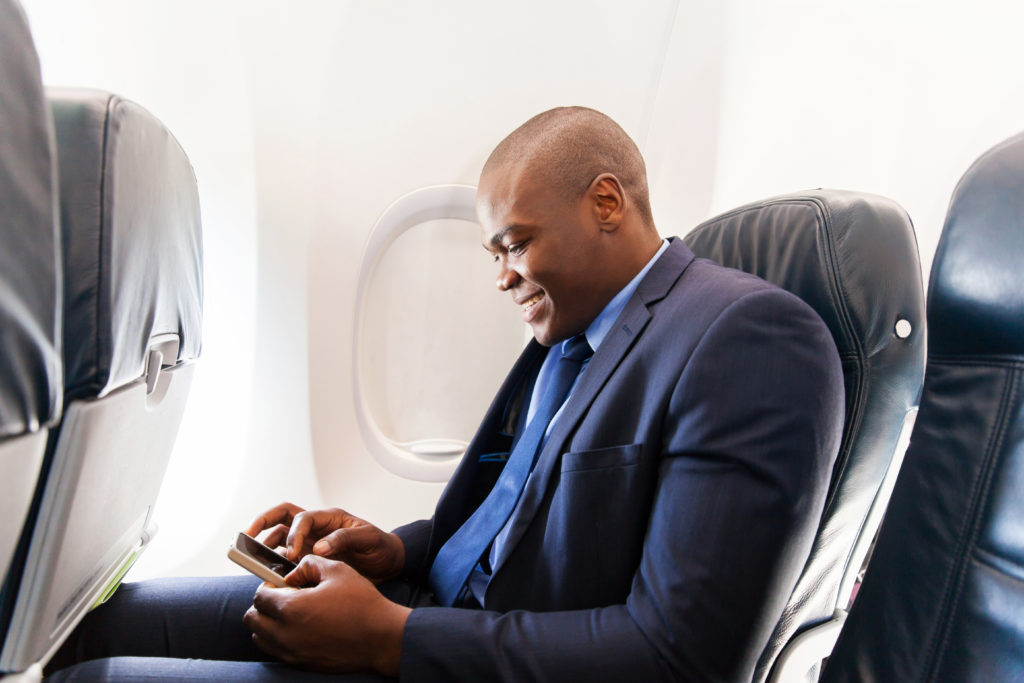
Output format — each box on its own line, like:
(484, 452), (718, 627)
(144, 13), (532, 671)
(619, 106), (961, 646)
(480, 106), (654, 227)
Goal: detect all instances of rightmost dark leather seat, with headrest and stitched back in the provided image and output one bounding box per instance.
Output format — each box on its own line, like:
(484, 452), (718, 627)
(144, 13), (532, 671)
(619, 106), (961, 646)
(825, 134), (1024, 681)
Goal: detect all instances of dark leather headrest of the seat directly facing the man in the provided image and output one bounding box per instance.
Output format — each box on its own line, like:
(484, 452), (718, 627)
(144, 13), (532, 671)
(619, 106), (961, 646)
(47, 89), (203, 396)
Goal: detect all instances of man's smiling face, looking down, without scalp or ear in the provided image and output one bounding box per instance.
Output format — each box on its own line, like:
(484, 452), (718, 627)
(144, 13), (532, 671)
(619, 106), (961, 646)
(476, 165), (613, 346)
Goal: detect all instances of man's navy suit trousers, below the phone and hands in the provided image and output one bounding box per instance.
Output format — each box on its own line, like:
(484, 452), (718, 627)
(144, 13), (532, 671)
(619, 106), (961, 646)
(46, 575), (436, 683)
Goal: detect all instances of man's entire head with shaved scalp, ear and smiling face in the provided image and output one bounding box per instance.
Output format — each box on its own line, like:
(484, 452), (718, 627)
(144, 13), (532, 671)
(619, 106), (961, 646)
(476, 106), (662, 345)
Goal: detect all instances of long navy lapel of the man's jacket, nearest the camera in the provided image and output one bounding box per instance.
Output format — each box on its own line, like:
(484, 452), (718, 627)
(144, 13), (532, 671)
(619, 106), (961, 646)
(494, 238), (694, 572)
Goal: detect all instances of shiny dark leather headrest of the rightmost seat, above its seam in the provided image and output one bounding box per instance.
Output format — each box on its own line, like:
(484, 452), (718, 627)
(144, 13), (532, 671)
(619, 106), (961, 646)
(928, 133), (1024, 355)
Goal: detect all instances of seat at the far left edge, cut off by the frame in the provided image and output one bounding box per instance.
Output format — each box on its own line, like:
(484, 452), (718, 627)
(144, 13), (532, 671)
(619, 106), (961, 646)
(0, 0), (61, 578)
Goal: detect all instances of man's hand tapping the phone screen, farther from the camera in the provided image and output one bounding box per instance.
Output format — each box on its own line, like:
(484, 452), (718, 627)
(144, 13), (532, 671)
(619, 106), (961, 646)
(246, 503), (406, 584)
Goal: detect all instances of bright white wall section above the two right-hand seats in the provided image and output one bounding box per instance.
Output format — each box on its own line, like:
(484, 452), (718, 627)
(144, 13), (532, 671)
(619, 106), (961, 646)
(712, 0), (1024, 281)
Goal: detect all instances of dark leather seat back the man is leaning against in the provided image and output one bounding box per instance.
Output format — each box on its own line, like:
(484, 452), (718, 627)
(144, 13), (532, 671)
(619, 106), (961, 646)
(685, 189), (925, 681)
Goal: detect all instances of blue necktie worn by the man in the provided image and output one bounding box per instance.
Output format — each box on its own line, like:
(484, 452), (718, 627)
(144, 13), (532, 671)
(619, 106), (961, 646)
(429, 334), (594, 606)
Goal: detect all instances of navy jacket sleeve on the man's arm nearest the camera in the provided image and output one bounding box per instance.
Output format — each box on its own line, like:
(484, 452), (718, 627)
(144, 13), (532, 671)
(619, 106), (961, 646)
(400, 290), (844, 682)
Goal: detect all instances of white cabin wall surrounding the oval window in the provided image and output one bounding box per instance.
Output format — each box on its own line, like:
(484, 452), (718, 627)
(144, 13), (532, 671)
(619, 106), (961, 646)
(23, 0), (1024, 579)
